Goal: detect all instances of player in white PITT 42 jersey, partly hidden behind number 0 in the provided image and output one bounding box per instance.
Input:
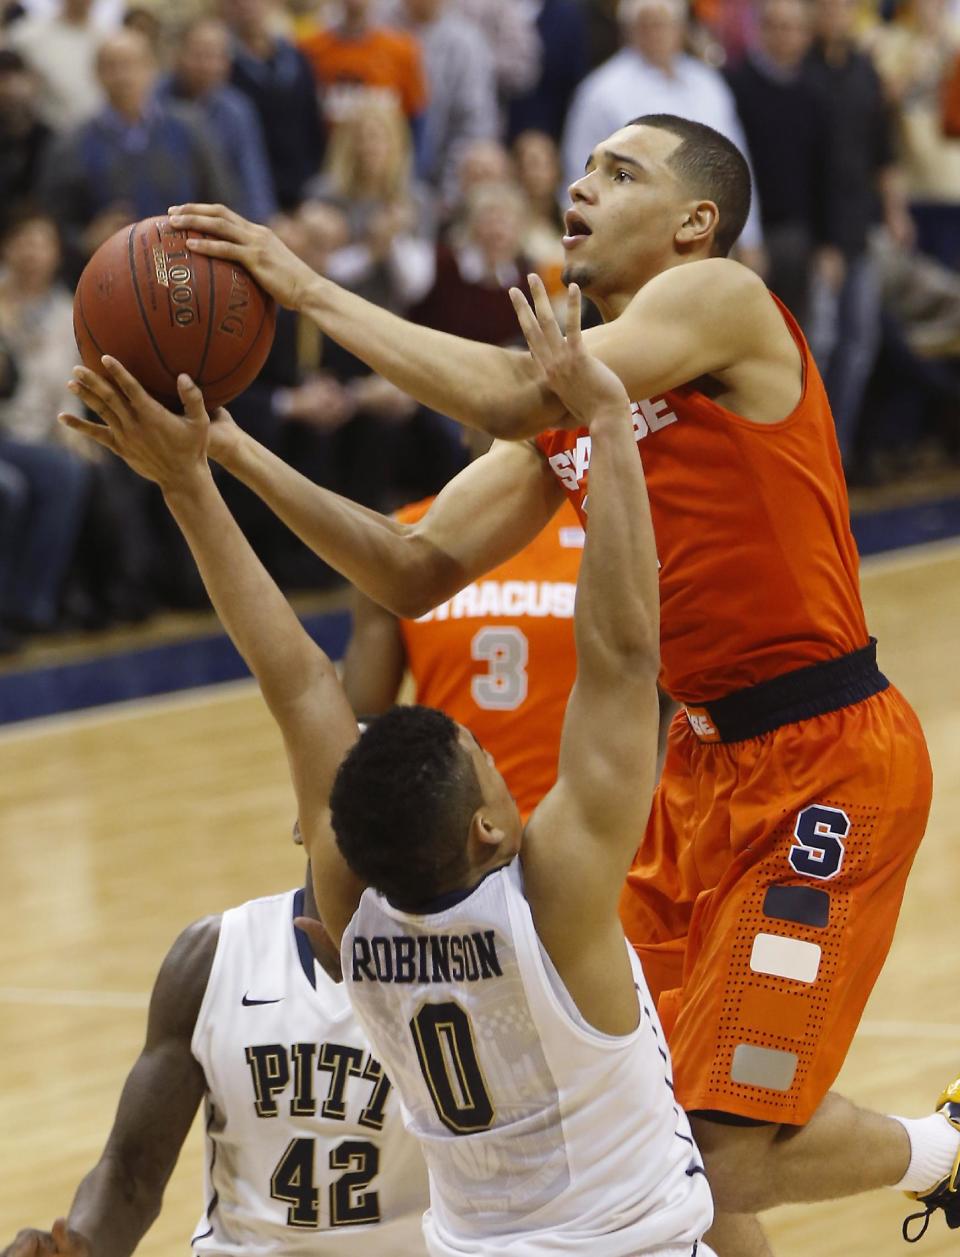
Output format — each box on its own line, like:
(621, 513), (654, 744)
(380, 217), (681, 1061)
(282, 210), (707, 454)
(4, 881), (427, 1257)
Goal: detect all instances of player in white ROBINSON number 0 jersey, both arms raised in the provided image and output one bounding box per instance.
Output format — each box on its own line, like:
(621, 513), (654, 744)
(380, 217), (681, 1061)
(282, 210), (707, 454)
(60, 287), (712, 1257)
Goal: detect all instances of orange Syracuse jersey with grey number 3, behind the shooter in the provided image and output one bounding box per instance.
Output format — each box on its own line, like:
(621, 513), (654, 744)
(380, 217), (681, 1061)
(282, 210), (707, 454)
(397, 499), (583, 817)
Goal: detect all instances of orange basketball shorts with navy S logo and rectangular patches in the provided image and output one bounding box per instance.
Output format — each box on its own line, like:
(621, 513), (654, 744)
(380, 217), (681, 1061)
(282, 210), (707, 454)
(621, 686), (932, 1125)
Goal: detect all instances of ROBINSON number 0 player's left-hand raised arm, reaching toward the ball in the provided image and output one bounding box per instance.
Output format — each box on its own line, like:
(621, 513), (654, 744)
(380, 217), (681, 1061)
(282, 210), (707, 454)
(60, 358), (362, 941)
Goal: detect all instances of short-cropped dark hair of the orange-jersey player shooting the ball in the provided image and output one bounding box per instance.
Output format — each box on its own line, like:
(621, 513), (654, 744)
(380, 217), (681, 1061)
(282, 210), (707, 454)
(627, 113), (750, 256)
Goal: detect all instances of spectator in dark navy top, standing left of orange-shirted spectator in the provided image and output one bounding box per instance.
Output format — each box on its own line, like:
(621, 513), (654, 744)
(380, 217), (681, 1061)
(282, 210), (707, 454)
(221, 0), (323, 210)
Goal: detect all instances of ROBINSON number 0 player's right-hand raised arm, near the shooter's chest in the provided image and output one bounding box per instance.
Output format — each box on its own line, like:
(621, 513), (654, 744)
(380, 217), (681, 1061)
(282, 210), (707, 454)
(514, 277), (660, 1024)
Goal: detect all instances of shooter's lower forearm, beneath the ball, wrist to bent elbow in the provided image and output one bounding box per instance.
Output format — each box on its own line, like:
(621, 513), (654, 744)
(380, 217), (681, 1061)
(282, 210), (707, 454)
(221, 436), (460, 616)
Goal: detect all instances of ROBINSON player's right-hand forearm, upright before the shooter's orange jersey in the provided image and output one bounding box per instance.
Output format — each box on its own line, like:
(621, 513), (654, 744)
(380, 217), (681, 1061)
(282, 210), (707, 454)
(574, 407), (660, 678)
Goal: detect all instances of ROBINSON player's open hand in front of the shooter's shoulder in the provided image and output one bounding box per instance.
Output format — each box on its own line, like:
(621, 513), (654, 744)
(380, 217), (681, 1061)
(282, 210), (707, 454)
(510, 274), (630, 426)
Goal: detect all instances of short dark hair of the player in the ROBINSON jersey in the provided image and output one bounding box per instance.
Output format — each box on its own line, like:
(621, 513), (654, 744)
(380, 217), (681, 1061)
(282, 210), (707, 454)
(330, 706), (484, 909)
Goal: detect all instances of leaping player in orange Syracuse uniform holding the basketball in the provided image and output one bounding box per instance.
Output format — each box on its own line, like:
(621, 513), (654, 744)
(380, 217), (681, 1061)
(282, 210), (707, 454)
(160, 114), (960, 1257)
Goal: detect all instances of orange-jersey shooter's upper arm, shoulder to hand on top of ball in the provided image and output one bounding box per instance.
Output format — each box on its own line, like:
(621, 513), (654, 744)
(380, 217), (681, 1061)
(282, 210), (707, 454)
(171, 205), (795, 440)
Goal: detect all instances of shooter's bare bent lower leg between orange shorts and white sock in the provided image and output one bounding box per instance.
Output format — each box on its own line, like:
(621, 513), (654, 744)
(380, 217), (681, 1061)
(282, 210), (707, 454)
(694, 1091), (910, 1216)
